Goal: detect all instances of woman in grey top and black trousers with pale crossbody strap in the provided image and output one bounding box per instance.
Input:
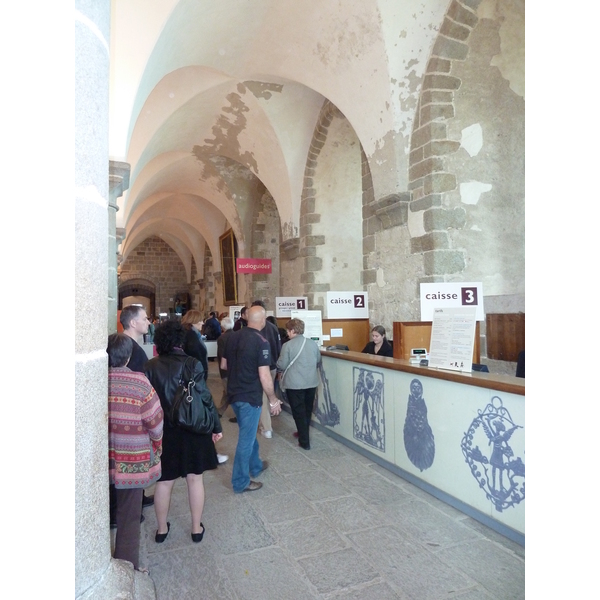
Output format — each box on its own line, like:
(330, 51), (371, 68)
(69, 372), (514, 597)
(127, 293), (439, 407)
(277, 319), (321, 450)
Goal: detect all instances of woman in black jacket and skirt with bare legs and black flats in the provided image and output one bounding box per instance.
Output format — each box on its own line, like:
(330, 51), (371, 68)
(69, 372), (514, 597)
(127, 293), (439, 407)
(145, 321), (223, 544)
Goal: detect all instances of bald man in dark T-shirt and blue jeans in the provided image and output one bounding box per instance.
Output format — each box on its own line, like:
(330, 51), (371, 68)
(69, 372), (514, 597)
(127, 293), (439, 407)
(221, 306), (281, 494)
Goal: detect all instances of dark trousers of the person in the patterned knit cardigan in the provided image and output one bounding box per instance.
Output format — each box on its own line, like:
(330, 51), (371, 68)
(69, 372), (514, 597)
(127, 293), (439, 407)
(114, 489), (144, 569)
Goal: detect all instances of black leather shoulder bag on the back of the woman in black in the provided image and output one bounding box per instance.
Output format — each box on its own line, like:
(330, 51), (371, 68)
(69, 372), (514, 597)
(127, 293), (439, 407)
(169, 357), (215, 434)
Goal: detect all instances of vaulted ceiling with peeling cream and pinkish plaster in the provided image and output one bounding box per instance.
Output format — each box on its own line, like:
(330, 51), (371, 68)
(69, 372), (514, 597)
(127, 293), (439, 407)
(109, 0), (448, 282)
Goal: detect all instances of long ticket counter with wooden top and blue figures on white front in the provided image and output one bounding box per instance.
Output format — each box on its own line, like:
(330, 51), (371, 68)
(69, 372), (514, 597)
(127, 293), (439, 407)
(312, 350), (525, 545)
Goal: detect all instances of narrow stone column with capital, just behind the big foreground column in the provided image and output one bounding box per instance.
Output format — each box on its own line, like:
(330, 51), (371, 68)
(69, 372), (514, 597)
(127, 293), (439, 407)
(108, 160), (131, 334)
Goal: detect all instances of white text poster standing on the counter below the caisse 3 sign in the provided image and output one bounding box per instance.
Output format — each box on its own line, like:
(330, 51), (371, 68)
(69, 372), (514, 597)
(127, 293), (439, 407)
(429, 306), (477, 371)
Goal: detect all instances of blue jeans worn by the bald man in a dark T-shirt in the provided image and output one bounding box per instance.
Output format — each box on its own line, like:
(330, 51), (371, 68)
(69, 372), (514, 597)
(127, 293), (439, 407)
(231, 402), (262, 494)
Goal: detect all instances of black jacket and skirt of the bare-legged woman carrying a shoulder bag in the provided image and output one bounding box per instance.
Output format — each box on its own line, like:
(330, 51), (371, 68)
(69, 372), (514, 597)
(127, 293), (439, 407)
(145, 349), (222, 481)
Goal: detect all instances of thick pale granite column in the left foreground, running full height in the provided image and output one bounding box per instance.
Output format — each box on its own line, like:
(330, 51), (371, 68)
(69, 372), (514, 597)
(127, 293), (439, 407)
(74, 0), (153, 600)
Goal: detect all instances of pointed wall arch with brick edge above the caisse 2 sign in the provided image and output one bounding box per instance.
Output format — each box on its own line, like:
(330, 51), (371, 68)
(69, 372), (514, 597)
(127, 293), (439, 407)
(298, 100), (363, 310)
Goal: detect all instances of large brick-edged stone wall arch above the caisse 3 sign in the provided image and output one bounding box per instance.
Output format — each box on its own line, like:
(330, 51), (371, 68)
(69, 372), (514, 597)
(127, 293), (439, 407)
(408, 0), (524, 296)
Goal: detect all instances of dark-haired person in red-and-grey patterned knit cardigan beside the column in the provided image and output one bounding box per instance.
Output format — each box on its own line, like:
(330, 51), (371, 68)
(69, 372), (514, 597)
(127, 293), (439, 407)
(107, 333), (163, 569)
